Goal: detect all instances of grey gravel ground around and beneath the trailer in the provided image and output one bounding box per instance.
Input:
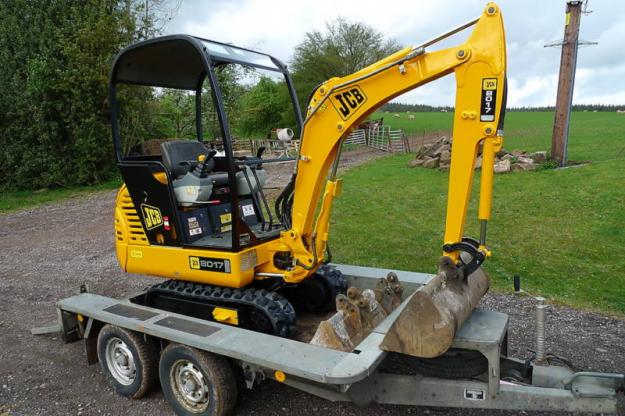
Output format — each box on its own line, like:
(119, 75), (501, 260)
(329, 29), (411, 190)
(0, 148), (625, 416)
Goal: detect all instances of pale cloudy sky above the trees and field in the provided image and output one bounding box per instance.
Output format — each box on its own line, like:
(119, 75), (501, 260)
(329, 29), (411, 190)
(166, 0), (625, 106)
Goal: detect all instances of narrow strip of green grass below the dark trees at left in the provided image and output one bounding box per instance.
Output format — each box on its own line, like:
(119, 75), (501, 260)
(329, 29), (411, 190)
(0, 180), (121, 213)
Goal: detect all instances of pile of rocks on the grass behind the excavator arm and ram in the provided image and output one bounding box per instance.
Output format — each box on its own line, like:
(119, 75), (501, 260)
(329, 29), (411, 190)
(408, 137), (547, 173)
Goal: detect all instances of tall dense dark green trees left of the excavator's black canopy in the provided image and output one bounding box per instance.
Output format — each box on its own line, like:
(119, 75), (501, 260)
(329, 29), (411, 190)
(0, 0), (174, 190)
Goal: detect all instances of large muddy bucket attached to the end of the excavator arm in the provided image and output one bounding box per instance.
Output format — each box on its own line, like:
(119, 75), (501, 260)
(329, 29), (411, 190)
(380, 257), (490, 358)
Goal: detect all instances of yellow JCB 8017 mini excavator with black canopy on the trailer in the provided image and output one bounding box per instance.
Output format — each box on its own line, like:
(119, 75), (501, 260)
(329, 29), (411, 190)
(110, 3), (506, 357)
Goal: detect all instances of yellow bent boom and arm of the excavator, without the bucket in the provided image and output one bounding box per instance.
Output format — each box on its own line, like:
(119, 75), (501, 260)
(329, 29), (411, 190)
(261, 3), (506, 283)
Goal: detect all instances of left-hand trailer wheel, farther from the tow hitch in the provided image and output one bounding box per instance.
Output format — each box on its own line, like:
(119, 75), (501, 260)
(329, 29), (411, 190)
(98, 325), (158, 399)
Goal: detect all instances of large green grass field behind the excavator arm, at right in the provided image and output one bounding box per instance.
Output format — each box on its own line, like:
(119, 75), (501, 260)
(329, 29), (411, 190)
(331, 113), (625, 315)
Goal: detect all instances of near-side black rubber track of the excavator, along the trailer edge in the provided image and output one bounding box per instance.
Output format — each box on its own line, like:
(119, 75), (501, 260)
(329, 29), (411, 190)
(140, 280), (295, 337)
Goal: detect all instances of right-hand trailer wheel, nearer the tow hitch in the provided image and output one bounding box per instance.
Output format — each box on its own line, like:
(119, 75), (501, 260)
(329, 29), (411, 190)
(159, 344), (237, 416)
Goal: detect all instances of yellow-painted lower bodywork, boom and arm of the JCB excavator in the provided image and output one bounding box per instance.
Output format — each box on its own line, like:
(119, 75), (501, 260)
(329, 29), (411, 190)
(115, 3), (506, 287)
